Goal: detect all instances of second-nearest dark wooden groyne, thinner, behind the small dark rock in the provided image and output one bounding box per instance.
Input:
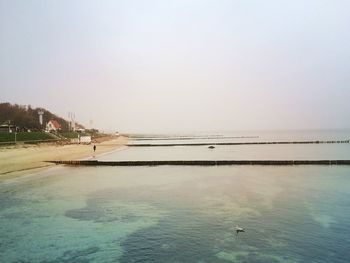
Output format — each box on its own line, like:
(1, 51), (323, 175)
(127, 140), (349, 147)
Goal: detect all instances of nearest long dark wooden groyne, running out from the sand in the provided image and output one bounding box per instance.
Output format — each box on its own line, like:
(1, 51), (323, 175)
(47, 160), (350, 166)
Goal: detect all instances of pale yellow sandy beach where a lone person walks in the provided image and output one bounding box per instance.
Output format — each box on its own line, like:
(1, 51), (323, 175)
(0, 136), (128, 180)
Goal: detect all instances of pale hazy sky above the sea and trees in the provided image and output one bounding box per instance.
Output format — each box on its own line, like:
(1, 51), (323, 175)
(0, 0), (350, 133)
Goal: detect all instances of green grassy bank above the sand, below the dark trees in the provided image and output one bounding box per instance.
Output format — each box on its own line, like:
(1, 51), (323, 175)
(0, 132), (56, 143)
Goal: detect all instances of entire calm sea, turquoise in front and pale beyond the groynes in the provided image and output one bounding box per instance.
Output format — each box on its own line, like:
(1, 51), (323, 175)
(0, 130), (350, 263)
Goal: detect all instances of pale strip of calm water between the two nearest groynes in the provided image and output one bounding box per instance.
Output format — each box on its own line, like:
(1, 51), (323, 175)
(98, 143), (350, 161)
